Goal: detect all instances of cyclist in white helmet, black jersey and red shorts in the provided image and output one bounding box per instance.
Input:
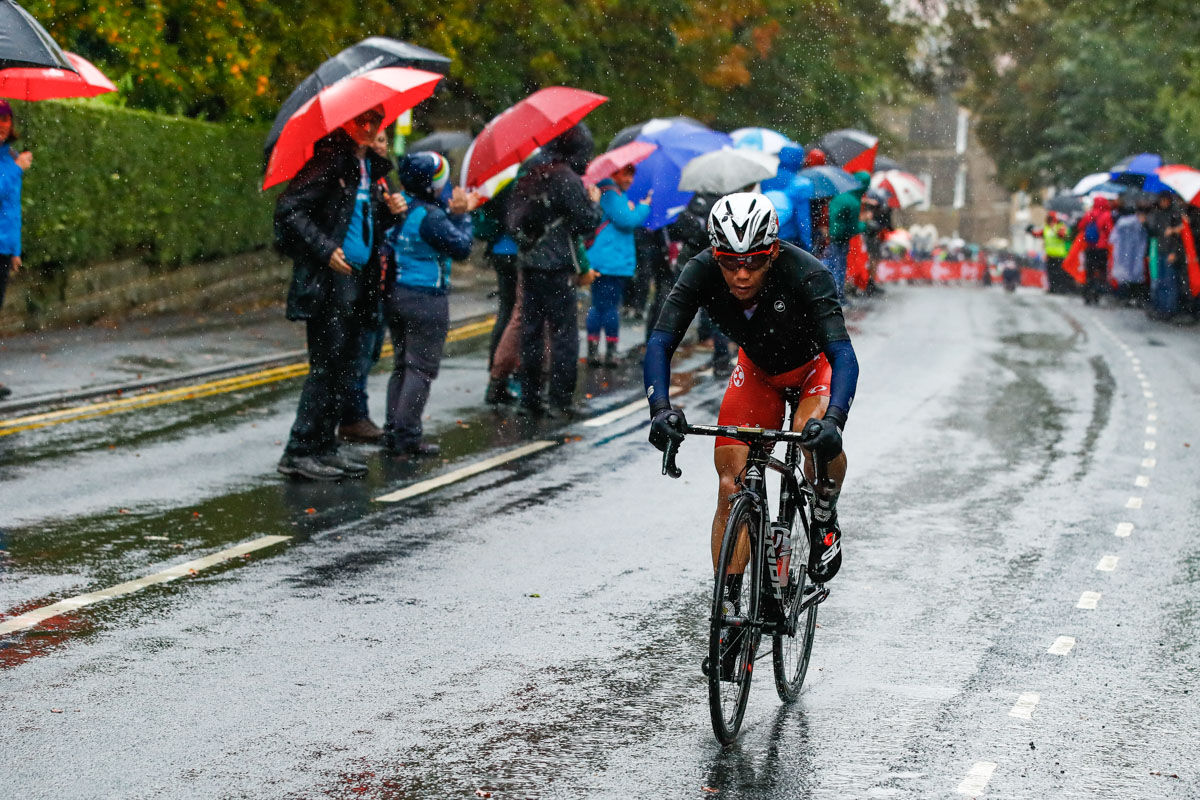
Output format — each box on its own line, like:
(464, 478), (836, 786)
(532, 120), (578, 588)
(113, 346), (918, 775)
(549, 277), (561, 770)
(643, 192), (858, 596)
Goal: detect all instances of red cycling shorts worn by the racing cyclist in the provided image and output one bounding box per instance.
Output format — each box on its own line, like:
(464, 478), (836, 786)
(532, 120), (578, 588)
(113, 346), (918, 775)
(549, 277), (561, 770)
(715, 348), (833, 447)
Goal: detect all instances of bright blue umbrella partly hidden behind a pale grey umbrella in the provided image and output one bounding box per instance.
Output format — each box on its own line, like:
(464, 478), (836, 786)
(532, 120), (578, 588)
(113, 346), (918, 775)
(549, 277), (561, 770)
(629, 120), (733, 230)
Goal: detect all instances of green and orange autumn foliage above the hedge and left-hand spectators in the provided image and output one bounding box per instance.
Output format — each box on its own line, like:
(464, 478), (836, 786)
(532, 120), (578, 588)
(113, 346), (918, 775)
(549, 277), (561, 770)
(26, 0), (914, 138)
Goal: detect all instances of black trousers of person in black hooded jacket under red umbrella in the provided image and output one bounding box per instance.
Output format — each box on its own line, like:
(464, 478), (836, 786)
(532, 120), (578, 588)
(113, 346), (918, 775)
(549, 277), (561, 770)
(521, 270), (580, 407)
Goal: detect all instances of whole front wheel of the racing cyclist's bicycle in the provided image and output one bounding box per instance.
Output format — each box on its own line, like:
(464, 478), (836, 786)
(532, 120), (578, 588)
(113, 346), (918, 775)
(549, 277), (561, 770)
(708, 498), (762, 745)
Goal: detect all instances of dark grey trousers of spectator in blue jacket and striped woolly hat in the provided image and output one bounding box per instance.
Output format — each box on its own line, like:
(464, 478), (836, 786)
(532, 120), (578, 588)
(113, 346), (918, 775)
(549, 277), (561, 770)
(384, 287), (450, 449)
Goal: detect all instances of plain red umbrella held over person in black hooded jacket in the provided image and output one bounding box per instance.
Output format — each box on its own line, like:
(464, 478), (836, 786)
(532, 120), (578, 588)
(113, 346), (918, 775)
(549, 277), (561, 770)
(463, 86), (608, 188)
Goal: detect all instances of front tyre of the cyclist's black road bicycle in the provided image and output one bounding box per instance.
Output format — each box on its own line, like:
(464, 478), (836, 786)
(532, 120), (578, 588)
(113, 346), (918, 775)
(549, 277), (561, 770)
(708, 498), (762, 745)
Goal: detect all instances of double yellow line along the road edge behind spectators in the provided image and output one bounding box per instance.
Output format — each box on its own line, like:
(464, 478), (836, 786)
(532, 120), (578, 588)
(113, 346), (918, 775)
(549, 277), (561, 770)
(0, 317), (496, 437)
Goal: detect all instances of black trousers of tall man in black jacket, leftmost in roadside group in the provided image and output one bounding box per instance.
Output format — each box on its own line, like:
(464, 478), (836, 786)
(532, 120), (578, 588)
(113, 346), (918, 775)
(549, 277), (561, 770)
(286, 271), (372, 456)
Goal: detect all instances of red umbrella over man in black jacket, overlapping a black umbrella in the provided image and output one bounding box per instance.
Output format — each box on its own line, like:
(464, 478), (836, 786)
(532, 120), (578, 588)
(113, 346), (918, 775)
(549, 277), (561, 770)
(263, 67), (442, 190)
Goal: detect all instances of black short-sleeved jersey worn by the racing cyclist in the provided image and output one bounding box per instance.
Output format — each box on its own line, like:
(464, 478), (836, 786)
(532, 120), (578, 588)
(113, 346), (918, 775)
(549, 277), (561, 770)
(654, 242), (850, 375)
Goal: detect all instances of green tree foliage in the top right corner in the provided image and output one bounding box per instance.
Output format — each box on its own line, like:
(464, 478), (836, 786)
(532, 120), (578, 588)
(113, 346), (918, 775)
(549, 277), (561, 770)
(942, 0), (1200, 188)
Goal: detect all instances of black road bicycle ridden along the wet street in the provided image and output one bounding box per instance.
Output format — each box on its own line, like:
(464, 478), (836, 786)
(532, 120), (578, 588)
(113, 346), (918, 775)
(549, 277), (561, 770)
(662, 393), (829, 745)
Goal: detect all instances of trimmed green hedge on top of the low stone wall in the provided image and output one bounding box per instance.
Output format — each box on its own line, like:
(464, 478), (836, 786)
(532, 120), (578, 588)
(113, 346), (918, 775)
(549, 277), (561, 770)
(13, 101), (274, 266)
